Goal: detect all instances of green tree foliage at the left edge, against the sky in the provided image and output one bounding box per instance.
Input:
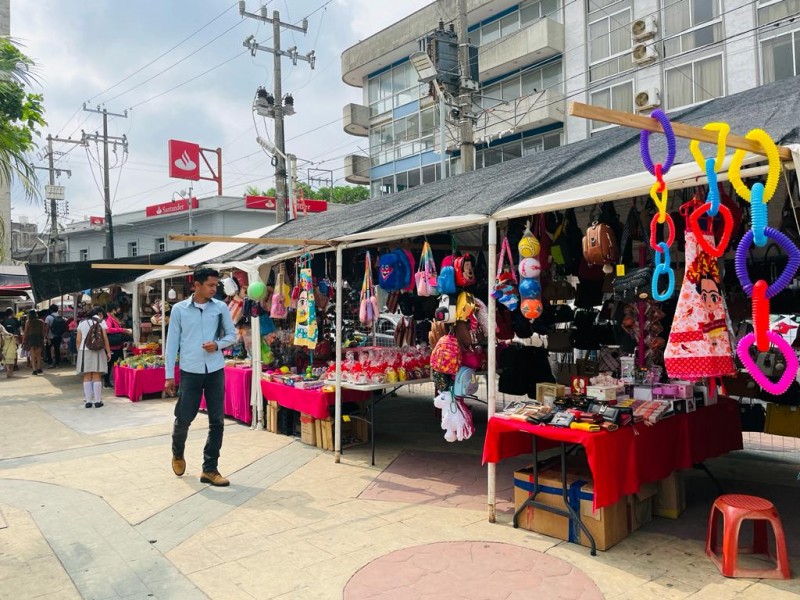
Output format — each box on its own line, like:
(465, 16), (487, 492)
(0, 38), (47, 204)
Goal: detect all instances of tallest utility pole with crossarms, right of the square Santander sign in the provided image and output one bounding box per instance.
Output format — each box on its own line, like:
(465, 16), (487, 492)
(239, 0), (316, 223)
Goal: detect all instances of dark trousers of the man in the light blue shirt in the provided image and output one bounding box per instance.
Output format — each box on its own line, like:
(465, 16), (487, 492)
(172, 369), (225, 473)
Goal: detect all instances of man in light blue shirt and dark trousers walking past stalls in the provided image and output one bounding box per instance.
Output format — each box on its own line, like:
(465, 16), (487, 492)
(164, 268), (236, 486)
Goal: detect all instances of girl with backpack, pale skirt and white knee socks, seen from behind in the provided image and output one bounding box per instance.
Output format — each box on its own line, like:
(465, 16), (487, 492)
(75, 307), (111, 408)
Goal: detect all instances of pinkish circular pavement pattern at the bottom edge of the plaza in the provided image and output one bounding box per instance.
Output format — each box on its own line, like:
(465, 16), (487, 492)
(344, 542), (603, 600)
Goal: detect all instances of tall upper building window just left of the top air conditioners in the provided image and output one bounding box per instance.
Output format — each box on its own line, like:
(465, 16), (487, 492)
(589, 0), (633, 81)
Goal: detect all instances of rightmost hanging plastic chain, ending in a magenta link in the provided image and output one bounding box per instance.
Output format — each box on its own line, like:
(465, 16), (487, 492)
(728, 129), (800, 396)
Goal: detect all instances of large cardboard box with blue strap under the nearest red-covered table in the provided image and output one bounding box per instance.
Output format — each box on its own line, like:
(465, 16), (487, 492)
(514, 468), (628, 550)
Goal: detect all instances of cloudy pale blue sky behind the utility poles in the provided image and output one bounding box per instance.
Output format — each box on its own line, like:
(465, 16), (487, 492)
(11, 0), (431, 228)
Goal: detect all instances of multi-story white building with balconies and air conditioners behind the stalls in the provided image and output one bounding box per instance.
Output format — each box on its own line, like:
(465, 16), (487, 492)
(342, 0), (800, 196)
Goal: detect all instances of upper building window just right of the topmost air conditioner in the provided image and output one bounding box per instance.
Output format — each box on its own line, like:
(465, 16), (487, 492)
(664, 0), (722, 56)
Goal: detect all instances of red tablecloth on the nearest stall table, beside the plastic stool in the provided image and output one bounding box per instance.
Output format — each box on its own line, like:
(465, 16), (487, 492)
(483, 398), (742, 508)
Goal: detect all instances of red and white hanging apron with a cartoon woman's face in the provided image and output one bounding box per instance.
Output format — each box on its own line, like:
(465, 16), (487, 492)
(664, 228), (736, 380)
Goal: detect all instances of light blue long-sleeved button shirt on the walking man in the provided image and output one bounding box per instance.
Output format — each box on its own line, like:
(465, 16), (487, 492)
(164, 296), (236, 379)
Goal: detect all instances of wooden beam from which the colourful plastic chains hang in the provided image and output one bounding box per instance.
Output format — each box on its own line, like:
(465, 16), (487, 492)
(569, 102), (792, 161)
